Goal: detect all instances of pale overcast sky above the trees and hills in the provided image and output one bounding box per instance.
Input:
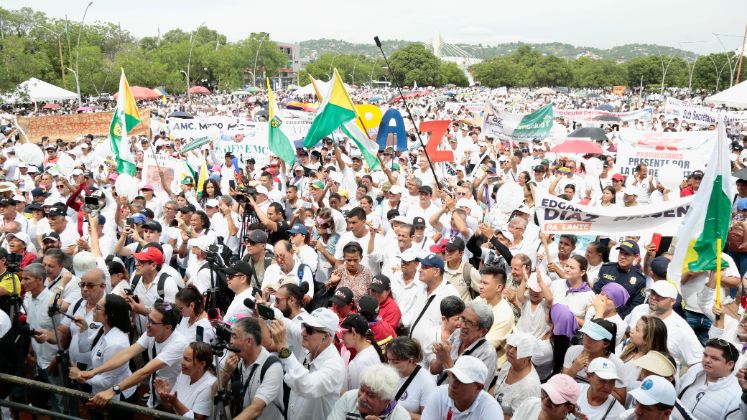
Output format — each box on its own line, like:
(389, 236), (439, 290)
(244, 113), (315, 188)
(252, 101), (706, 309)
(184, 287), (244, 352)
(7, 0), (747, 54)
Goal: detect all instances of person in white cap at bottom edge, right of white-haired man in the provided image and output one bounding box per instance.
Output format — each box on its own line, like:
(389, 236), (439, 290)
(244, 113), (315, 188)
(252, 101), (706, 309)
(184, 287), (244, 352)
(420, 356), (503, 420)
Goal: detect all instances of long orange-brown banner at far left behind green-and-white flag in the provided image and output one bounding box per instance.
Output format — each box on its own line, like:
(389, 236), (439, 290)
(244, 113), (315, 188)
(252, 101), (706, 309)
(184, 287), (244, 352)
(18, 109), (150, 143)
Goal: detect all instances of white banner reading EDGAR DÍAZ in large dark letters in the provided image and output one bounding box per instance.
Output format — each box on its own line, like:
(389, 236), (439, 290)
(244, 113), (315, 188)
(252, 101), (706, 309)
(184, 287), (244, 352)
(535, 192), (693, 236)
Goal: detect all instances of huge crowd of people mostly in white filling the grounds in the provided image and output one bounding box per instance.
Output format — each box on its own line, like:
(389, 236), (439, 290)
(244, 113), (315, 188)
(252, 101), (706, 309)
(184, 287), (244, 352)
(0, 83), (747, 420)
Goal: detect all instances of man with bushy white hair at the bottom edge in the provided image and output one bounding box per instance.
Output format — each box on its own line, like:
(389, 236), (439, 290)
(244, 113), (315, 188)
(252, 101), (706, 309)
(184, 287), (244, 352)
(327, 365), (410, 420)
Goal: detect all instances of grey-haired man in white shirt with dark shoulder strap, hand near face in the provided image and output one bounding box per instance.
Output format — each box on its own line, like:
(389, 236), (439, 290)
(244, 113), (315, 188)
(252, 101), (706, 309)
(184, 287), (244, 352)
(220, 317), (285, 420)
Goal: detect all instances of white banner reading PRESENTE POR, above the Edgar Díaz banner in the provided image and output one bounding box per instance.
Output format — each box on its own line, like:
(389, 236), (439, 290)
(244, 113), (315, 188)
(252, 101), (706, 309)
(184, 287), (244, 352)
(617, 130), (717, 176)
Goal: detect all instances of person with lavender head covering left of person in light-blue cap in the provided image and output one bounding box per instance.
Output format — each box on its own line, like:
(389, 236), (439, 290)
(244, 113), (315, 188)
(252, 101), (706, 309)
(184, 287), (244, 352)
(532, 303), (579, 381)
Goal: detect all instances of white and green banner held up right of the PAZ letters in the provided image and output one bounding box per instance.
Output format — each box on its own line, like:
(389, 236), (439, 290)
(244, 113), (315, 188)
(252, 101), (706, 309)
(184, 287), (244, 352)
(482, 105), (553, 139)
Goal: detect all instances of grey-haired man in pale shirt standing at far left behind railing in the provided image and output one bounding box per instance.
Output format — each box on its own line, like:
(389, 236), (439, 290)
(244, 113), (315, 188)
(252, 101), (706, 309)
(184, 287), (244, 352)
(21, 263), (62, 413)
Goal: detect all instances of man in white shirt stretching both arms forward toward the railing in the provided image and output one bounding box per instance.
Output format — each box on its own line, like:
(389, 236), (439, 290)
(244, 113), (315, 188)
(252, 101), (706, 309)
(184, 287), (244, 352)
(80, 302), (189, 407)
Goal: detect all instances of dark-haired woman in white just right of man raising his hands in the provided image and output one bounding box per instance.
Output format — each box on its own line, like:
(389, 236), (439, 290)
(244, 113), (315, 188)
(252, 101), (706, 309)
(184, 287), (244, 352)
(340, 314), (386, 391)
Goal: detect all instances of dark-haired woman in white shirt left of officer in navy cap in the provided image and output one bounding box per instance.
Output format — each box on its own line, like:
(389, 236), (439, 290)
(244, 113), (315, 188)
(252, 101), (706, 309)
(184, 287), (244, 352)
(550, 255), (594, 326)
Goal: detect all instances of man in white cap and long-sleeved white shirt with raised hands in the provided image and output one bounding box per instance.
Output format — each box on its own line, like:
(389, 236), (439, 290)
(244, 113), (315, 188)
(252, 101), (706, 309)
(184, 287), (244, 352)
(265, 308), (345, 419)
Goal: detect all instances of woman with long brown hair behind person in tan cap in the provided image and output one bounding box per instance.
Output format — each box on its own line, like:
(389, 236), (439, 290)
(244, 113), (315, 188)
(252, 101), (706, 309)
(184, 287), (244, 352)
(620, 315), (669, 389)
